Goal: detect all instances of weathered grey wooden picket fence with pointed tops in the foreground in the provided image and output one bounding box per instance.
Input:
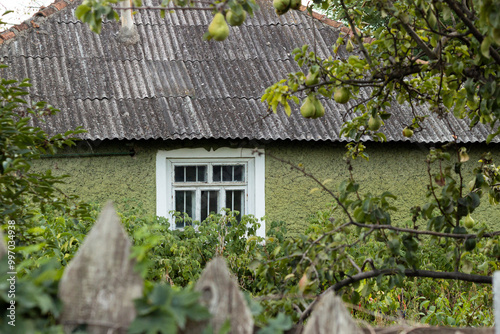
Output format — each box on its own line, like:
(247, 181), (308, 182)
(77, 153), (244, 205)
(4, 204), (494, 334)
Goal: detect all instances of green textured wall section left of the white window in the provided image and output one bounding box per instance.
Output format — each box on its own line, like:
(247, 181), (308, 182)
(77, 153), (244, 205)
(34, 141), (157, 215)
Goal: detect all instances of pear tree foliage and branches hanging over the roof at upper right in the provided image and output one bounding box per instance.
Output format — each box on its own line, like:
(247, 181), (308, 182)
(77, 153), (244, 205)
(262, 0), (500, 156)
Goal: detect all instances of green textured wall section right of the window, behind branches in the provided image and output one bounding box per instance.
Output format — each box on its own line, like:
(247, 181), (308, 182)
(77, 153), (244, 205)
(266, 142), (500, 233)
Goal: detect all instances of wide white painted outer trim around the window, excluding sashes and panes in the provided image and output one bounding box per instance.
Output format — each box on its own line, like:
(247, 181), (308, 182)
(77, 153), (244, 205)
(156, 147), (266, 237)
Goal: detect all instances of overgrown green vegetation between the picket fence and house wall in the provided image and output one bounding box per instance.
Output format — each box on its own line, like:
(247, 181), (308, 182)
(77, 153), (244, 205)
(0, 201), (498, 333)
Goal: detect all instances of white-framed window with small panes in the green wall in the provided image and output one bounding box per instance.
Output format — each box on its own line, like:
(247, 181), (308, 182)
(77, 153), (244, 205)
(156, 148), (265, 236)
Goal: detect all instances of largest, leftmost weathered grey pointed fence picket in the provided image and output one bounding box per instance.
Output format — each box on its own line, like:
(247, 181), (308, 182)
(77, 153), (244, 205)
(59, 203), (143, 334)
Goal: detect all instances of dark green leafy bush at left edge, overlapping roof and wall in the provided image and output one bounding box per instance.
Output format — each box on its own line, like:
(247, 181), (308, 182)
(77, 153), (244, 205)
(0, 75), (89, 242)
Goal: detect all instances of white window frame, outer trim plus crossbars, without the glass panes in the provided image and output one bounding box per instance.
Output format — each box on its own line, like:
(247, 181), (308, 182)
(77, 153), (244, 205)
(156, 147), (266, 237)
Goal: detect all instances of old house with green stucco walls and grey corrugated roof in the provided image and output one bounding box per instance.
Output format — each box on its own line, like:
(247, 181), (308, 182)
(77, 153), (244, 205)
(0, 0), (500, 234)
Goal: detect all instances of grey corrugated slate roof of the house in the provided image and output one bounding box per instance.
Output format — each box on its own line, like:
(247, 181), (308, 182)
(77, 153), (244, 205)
(0, 0), (489, 143)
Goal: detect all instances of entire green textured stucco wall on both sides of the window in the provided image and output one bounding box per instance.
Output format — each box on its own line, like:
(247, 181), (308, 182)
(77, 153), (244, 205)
(34, 141), (500, 234)
